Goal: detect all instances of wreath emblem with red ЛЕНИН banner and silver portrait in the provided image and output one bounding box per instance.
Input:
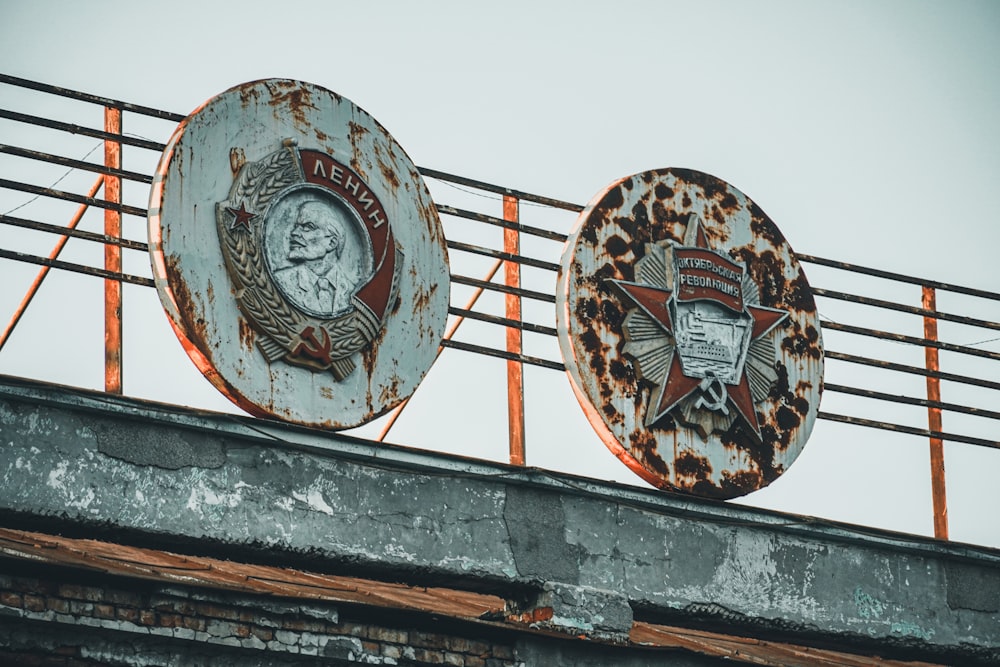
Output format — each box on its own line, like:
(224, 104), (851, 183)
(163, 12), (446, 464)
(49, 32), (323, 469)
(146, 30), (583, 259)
(216, 140), (401, 380)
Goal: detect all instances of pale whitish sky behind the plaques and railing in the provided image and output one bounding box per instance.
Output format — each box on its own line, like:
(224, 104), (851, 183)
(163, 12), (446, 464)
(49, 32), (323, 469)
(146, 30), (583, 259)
(0, 0), (1000, 546)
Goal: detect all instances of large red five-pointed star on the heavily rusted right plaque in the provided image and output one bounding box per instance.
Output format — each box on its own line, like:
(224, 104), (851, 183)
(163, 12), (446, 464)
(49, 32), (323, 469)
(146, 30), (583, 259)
(609, 231), (788, 437)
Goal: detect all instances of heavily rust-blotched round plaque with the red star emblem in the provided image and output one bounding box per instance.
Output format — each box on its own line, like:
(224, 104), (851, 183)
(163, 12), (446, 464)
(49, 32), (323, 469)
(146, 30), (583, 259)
(556, 169), (823, 498)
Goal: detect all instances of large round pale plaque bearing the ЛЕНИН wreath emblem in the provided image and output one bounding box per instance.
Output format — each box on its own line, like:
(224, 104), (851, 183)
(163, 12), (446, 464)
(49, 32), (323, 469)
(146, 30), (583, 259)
(149, 79), (449, 429)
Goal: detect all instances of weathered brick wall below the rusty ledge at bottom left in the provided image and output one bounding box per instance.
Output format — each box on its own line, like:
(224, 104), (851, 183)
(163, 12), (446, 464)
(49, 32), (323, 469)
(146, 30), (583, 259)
(0, 561), (523, 667)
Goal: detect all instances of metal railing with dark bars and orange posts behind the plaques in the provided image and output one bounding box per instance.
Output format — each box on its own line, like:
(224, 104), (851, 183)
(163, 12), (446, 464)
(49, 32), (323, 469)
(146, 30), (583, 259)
(0, 75), (1000, 538)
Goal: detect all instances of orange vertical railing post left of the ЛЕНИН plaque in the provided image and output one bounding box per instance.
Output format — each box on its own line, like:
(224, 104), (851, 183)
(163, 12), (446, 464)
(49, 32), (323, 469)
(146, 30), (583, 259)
(104, 107), (122, 394)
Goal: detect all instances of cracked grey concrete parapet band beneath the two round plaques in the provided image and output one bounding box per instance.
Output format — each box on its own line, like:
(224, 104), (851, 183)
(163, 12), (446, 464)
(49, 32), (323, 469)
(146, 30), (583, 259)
(0, 382), (1000, 659)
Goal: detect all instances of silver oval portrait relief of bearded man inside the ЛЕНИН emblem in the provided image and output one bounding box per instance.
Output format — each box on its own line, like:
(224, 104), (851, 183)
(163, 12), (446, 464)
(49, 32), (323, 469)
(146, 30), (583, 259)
(265, 187), (372, 318)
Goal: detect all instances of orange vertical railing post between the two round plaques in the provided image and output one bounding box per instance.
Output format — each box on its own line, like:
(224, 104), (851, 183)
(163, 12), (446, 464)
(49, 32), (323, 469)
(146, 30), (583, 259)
(503, 195), (525, 466)
